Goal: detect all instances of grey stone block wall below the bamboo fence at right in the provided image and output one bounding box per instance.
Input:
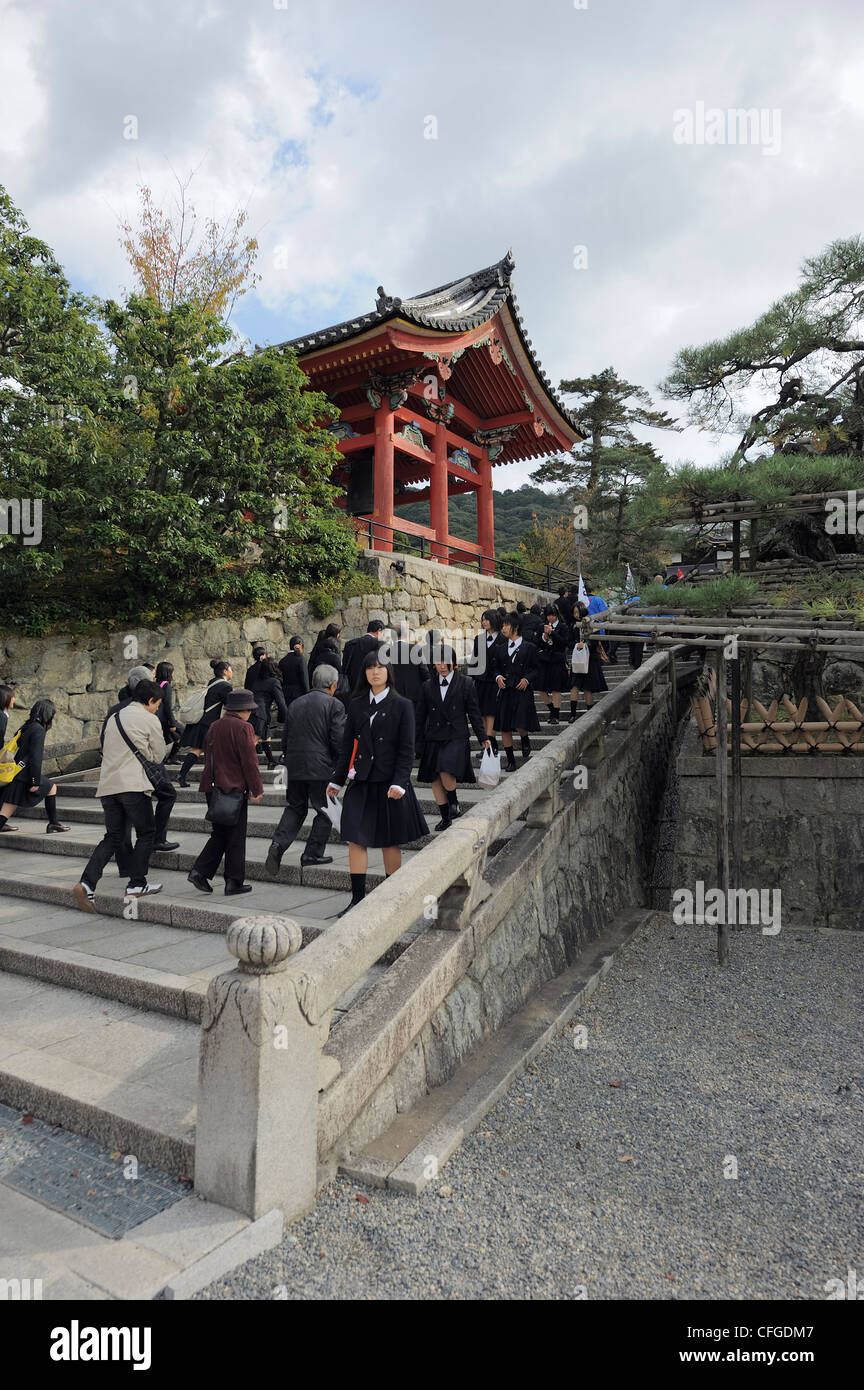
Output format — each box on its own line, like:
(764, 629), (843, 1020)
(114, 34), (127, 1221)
(672, 730), (864, 931)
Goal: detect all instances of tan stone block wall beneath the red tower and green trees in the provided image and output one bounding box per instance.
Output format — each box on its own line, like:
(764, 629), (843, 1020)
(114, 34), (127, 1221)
(0, 550), (547, 744)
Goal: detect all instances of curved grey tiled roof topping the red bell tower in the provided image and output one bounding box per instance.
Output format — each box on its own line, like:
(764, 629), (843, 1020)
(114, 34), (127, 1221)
(276, 252), (582, 435)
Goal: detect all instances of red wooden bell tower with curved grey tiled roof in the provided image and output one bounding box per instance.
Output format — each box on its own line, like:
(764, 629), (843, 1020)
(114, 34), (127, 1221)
(281, 254), (585, 574)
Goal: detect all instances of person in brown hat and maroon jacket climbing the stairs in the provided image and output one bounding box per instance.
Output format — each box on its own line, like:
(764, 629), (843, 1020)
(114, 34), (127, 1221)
(188, 691), (264, 897)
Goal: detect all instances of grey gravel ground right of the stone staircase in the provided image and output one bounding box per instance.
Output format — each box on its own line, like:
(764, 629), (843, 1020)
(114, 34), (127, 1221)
(200, 916), (864, 1300)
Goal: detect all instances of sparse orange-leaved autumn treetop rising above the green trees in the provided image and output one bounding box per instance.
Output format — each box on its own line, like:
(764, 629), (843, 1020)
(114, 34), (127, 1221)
(121, 174), (261, 318)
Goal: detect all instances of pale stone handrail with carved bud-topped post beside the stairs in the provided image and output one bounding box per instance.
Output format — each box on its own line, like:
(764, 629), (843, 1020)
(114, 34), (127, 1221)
(194, 651), (675, 1220)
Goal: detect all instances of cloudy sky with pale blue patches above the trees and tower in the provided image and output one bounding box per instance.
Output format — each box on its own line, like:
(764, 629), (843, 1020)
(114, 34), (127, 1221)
(0, 0), (864, 487)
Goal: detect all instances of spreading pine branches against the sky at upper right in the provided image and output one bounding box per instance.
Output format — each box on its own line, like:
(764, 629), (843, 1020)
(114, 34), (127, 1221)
(660, 236), (864, 461)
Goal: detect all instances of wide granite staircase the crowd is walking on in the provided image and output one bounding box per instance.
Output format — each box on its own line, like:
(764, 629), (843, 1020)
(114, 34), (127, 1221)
(0, 667), (629, 1175)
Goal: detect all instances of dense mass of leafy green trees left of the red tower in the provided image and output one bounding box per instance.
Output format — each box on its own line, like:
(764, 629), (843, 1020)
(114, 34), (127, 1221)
(0, 193), (357, 631)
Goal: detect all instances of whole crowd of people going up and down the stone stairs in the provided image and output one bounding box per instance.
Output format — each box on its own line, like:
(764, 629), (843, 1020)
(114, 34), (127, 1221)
(0, 580), (655, 915)
